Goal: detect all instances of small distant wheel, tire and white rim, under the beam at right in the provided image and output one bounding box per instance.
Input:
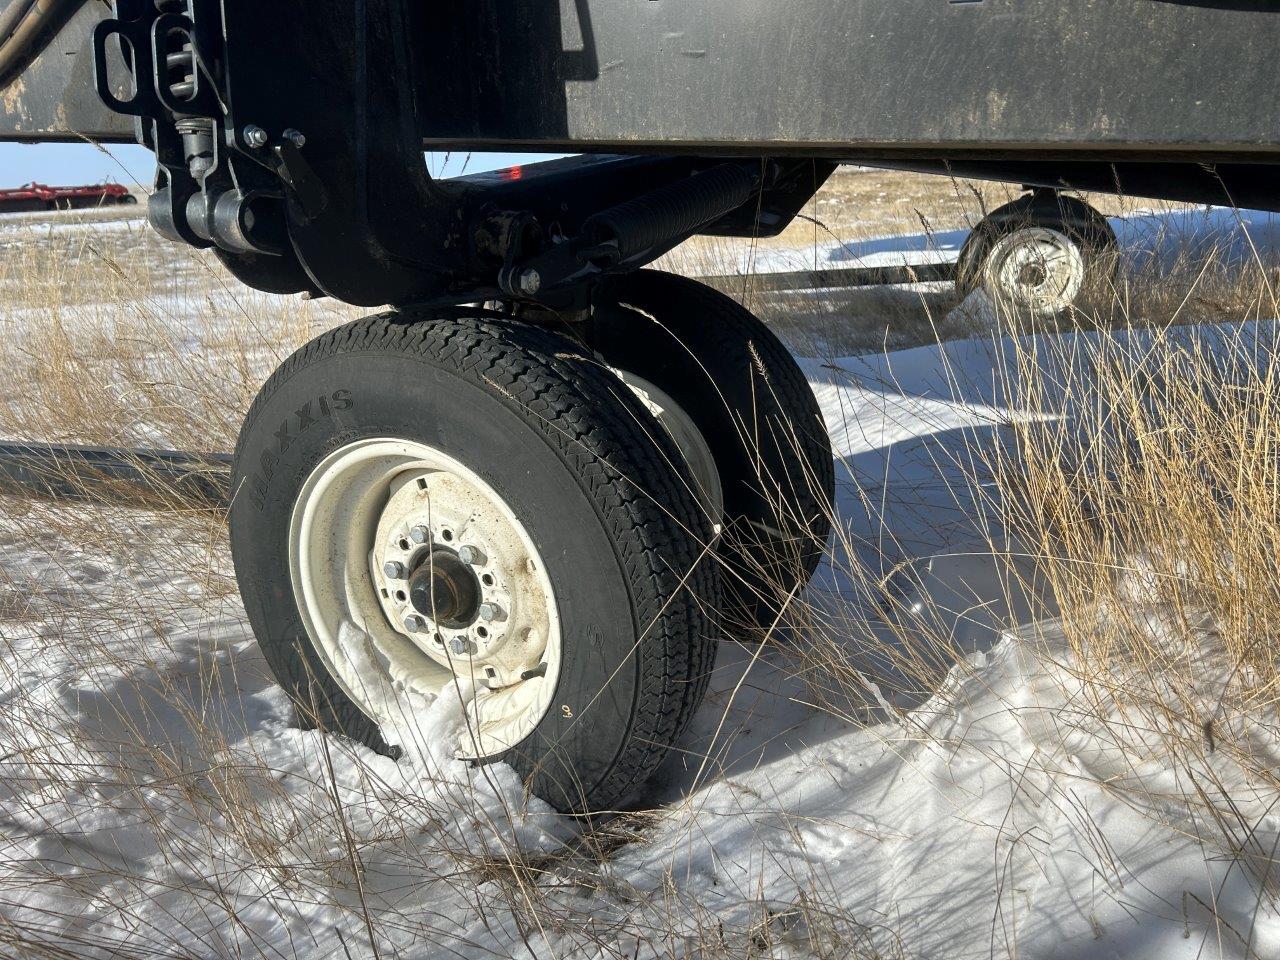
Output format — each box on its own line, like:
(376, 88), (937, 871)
(956, 191), (1116, 319)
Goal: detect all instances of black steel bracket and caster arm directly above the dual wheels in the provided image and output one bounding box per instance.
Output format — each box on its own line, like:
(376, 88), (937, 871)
(85, 0), (833, 308)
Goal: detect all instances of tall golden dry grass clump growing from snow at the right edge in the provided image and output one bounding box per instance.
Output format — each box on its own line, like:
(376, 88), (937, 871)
(1004, 324), (1280, 814)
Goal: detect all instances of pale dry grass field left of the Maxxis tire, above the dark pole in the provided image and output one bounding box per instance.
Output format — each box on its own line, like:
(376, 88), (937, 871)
(0, 207), (353, 452)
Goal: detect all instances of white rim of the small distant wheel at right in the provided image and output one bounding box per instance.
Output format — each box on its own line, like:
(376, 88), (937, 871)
(983, 227), (1084, 316)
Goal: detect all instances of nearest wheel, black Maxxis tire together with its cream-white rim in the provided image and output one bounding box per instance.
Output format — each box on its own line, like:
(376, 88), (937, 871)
(230, 312), (721, 812)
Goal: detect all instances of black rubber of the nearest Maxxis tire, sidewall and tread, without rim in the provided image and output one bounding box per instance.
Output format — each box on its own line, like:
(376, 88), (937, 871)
(230, 314), (721, 812)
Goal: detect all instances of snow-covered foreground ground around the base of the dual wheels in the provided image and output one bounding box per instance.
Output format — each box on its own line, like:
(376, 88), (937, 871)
(0, 212), (1280, 960)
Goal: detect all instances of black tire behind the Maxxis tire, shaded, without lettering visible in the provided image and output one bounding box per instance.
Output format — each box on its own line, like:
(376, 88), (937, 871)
(586, 270), (836, 636)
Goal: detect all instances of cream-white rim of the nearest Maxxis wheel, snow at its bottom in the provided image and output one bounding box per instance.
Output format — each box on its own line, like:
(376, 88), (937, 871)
(289, 439), (561, 758)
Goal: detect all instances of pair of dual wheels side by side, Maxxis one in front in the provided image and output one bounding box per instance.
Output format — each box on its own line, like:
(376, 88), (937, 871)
(230, 274), (831, 812)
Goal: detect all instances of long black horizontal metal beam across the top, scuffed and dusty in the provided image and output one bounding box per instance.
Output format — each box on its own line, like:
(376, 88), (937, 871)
(0, 0), (1280, 161)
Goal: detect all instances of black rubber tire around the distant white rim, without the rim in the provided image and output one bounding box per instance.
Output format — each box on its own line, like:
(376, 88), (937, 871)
(956, 191), (1117, 313)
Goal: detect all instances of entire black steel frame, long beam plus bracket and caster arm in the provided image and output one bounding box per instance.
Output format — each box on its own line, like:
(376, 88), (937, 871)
(0, 0), (1280, 308)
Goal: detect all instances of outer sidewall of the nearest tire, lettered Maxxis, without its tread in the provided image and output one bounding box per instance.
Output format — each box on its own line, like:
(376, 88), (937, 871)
(230, 349), (645, 808)
